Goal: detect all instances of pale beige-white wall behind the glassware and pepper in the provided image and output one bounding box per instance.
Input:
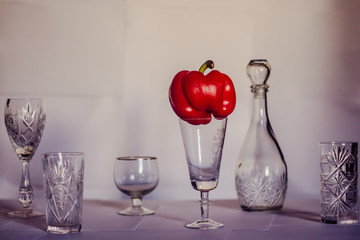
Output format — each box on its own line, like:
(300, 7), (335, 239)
(0, 0), (360, 202)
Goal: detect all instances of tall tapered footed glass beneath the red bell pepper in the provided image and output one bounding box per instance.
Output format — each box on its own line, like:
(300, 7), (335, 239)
(179, 118), (227, 229)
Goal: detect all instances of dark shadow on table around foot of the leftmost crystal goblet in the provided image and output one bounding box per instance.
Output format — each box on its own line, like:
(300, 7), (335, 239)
(0, 201), (46, 230)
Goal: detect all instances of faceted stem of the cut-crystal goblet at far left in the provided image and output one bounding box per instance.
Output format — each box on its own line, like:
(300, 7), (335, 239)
(19, 160), (34, 211)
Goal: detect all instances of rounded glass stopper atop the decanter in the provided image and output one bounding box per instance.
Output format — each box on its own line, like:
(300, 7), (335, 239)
(246, 59), (271, 90)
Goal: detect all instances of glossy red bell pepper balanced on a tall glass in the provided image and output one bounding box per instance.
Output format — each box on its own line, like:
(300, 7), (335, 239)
(169, 60), (236, 124)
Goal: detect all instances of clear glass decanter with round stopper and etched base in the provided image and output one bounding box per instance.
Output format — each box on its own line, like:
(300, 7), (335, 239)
(235, 60), (287, 211)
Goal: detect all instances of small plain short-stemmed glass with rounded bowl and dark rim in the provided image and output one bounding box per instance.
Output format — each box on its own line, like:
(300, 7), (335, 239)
(114, 156), (159, 216)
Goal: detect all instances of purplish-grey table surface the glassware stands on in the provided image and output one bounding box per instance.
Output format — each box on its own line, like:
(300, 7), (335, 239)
(0, 199), (360, 240)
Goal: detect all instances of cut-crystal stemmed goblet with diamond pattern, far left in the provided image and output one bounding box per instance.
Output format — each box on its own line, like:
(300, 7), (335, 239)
(4, 98), (46, 218)
